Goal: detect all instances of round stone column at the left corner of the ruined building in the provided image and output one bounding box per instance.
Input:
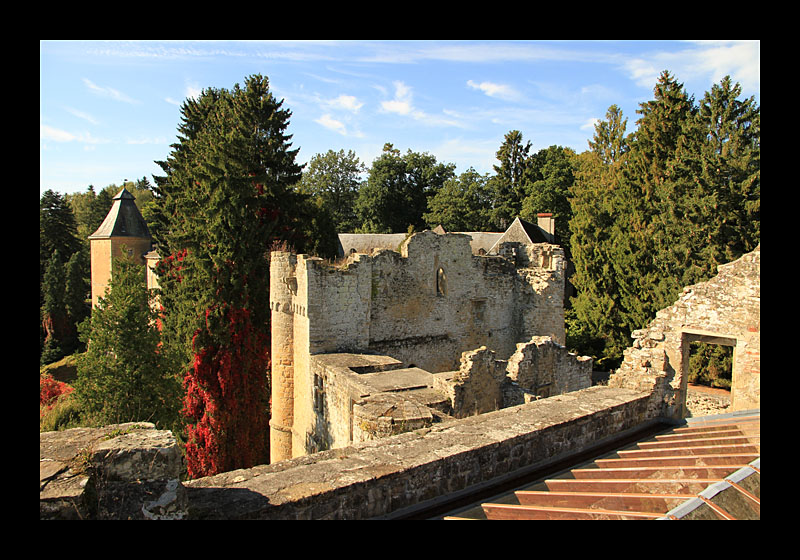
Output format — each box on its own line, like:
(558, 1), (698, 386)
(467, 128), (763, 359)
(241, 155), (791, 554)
(269, 251), (297, 463)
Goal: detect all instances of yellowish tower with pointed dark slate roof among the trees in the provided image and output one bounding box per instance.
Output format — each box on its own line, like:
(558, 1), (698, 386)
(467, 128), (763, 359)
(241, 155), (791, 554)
(89, 188), (153, 306)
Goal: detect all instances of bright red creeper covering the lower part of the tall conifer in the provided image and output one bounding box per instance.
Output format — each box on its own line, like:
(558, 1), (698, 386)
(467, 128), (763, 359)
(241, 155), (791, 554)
(182, 309), (269, 478)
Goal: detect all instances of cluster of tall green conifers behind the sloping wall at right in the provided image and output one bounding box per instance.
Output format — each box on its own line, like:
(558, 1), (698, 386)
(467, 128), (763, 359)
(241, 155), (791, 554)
(570, 72), (760, 370)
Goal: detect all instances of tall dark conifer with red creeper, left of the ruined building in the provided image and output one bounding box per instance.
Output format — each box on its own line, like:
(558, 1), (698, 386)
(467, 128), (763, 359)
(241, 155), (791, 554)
(154, 76), (308, 477)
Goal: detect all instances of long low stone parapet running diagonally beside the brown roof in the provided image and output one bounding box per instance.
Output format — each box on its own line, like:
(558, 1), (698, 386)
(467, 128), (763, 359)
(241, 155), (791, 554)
(185, 386), (654, 519)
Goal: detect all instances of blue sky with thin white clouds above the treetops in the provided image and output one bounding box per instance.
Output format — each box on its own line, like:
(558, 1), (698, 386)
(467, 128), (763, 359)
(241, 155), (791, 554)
(39, 40), (761, 195)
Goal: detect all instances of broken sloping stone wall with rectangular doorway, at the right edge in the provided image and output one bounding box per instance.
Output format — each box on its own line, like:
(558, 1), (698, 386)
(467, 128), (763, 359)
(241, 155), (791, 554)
(609, 245), (761, 418)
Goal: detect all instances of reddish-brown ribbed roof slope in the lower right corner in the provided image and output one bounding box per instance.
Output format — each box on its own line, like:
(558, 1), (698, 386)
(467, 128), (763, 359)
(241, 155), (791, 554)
(444, 411), (761, 520)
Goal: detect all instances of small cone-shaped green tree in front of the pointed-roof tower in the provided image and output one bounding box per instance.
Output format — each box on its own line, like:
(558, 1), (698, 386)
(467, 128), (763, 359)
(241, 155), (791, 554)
(74, 251), (180, 429)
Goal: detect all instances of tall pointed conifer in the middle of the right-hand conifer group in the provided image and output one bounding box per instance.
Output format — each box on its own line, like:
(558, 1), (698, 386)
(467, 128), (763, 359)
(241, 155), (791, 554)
(612, 71), (696, 332)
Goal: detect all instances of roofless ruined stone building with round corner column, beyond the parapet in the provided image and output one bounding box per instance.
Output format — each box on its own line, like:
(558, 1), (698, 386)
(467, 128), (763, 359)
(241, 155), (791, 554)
(270, 215), (591, 462)
